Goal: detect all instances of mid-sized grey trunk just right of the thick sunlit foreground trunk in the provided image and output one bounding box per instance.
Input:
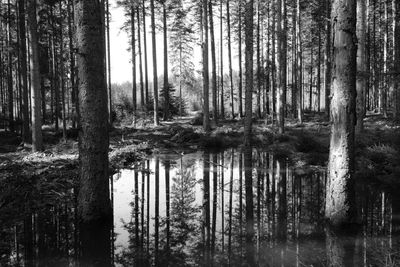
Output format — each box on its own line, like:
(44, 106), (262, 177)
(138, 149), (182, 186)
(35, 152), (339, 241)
(356, 0), (367, 133)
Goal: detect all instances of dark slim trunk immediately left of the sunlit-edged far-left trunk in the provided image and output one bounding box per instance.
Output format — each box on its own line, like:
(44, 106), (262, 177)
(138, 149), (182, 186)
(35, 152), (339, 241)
(18, 0), (31, 143)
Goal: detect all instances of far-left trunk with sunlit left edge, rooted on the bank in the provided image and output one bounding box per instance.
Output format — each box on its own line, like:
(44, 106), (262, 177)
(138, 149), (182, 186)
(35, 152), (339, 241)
(27, 0), (43, 152)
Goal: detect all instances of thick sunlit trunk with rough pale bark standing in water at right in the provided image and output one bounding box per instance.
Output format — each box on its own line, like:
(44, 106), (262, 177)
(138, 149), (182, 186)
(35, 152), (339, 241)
(325, 0), (357, 226)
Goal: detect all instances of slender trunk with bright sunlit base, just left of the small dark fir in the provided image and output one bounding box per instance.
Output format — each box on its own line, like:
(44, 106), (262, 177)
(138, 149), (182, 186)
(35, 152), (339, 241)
(150, 0), (160, 126)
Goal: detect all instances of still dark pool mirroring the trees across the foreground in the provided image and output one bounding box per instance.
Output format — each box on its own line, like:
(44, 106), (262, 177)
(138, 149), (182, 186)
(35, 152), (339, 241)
(0, 149), (400, 266)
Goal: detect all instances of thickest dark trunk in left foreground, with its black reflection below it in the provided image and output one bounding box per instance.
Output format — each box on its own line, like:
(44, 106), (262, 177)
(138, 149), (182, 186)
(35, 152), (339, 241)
(75, 0), (112, 266)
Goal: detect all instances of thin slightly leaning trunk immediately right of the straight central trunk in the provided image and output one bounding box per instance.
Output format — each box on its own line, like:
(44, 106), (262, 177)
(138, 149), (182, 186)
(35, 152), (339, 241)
(208, 0), (218, 125)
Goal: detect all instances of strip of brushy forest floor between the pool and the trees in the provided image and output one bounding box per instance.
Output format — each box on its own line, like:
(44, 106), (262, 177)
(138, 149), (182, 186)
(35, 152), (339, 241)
(0, 114), (400, 189)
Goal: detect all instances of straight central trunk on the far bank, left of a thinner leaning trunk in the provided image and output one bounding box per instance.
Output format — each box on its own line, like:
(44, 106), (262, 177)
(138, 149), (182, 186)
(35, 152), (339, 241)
(202, 0), (211, 132)
